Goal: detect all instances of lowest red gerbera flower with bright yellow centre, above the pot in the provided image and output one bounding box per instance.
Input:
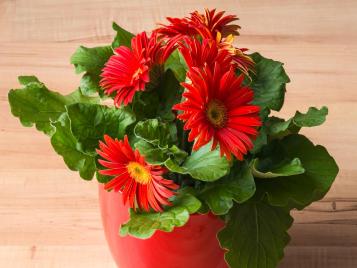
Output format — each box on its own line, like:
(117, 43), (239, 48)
(97, 135), (178, 211)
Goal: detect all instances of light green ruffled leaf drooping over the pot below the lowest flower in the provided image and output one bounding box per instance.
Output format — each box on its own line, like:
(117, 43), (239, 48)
(120, 193), (201, 239)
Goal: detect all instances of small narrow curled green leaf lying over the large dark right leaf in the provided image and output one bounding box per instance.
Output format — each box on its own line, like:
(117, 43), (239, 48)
(252, 158), (305, 179)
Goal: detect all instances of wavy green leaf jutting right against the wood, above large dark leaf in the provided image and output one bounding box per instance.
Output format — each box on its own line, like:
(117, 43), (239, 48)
(269, 106), (328, 138)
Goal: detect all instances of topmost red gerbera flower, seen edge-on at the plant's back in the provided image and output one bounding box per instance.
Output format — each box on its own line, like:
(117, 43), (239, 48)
(157, 9), (240, 40)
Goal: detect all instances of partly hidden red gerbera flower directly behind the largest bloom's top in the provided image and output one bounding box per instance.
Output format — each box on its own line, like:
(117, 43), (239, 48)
(179, 37), (232, 70)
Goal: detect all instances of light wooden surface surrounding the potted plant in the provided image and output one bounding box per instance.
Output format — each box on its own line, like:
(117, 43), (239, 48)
(0, 0), (357, 268)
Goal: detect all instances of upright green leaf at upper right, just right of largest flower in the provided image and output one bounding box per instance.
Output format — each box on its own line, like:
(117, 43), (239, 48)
(250, 53), (290, 111)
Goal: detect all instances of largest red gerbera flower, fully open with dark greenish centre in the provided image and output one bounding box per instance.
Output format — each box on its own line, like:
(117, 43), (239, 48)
(173, 63), (261, 160)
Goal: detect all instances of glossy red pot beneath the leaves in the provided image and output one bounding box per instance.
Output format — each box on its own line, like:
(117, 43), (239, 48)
(99, 185), (227, 268)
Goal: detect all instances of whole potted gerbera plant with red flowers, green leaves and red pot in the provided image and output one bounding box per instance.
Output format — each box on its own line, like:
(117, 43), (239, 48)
(9, 10), (338, 268)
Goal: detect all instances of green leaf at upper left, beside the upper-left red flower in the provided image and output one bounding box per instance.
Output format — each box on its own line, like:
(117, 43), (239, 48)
(71, 46), (113, 95)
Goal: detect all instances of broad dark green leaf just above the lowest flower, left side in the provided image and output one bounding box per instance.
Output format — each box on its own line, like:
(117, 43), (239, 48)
(67, 103), (135, 153)
